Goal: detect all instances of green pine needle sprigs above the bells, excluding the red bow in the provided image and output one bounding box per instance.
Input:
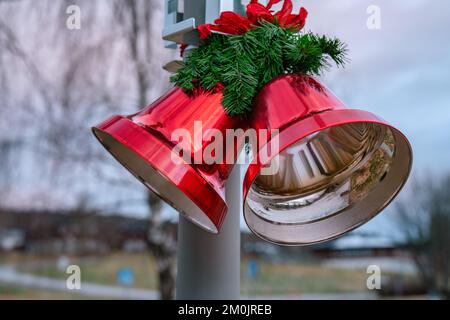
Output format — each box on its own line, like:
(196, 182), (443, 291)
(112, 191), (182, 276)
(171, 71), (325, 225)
(171, 22), (347, 116)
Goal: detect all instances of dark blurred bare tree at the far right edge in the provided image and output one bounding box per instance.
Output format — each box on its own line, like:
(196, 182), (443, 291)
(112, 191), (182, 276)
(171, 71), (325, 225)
(396, 175), (450, 298)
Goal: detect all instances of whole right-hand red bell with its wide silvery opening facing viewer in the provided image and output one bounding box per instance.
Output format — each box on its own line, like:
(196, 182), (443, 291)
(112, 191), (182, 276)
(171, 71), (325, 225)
(244, 75), (412, 245)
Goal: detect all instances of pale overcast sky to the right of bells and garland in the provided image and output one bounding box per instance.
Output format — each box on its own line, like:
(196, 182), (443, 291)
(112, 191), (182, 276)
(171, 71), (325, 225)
(0, 0), (450, 240)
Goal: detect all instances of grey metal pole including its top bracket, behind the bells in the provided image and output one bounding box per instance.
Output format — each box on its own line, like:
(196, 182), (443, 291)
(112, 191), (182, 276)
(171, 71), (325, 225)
(163, 0), (242, 299)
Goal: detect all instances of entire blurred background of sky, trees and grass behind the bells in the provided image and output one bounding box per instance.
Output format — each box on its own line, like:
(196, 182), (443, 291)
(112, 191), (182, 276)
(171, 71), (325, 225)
(0, 0), (450, 299)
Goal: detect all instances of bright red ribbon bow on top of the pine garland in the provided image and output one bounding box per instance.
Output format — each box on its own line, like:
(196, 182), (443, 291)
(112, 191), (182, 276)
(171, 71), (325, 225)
(198, 0), (308, 39)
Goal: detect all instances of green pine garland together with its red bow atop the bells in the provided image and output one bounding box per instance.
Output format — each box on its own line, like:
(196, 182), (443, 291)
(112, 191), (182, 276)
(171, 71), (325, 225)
(171, 0), (346, 116)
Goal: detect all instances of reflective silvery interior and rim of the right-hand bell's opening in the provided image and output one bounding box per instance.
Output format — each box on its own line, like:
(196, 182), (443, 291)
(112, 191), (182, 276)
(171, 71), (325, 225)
(244, 123), (411, 245)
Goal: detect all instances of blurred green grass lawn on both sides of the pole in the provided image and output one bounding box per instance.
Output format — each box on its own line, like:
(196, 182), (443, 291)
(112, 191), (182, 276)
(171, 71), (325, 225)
(0, 253), (367, 298)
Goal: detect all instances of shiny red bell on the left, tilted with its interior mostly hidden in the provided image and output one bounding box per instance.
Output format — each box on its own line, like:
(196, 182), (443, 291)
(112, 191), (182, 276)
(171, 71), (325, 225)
(93, 88), (244, 233)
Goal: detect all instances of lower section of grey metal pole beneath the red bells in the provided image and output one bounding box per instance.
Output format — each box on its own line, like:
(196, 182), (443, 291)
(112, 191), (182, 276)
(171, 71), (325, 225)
(176, 165), (242, 300)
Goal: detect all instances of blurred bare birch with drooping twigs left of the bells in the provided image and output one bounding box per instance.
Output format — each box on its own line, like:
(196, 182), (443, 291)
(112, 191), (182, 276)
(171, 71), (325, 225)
(0, 0), (176, 299)
